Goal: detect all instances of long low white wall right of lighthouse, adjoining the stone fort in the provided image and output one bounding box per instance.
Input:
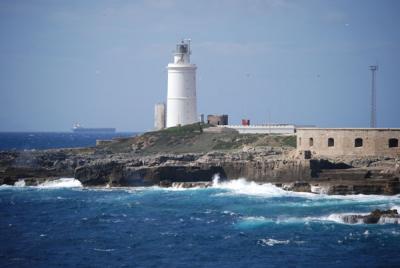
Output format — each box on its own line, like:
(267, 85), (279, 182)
(218, 124), (296, 135)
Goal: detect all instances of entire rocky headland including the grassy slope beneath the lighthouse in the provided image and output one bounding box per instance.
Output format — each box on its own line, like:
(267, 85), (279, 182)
(0, 124), (400, 194)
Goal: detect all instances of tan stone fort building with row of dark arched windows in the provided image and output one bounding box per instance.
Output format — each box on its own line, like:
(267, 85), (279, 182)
(296, 128), (400, 157)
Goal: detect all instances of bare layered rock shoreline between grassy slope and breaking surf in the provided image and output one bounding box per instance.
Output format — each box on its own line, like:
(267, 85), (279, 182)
(0, 144), (400, 195)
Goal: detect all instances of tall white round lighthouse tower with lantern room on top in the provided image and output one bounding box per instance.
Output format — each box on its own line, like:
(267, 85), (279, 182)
(167, 39), (198, 127)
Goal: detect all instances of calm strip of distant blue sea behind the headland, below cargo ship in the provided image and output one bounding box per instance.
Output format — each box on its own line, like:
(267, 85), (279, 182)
(0, 132), (137, 150)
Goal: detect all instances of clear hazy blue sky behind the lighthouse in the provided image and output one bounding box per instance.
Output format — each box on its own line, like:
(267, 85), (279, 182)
(0, 0), (400, 131)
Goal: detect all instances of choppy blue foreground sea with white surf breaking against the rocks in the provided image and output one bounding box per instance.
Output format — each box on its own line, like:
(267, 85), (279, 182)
(0, 133), (400, 268)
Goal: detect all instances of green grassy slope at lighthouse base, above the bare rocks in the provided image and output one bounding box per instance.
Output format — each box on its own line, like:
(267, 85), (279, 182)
(100, 124), (296, 154)
